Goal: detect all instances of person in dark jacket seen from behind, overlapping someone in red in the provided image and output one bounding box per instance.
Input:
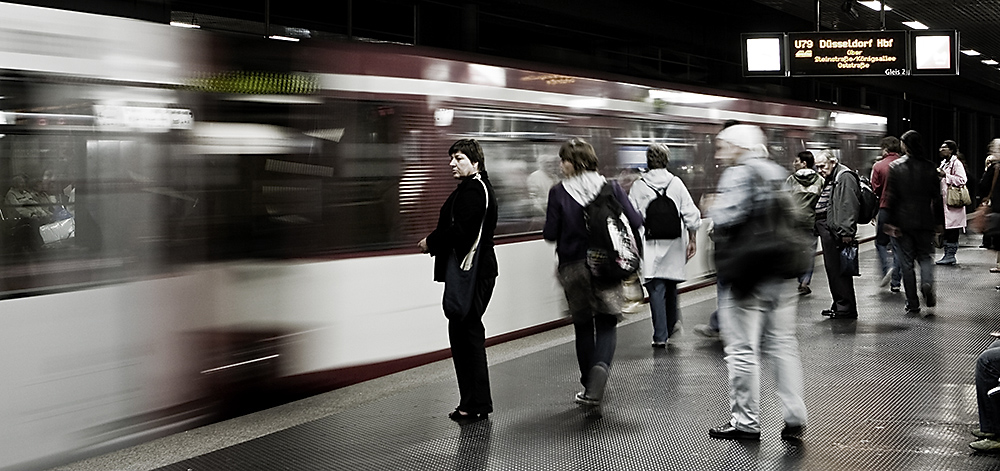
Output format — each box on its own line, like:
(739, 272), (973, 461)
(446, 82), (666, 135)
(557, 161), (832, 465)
(885, 130), (944, 313)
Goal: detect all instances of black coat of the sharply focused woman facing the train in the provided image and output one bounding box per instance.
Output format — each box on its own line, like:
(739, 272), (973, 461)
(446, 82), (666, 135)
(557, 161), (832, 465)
(427, 171), (498, 282)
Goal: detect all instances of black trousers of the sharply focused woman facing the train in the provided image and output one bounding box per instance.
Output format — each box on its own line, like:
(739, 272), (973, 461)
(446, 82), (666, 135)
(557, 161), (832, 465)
(448, 277), (497, 414)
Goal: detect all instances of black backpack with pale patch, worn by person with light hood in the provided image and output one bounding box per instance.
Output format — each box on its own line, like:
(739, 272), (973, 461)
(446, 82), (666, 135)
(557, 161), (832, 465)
(583, 182), (640, 280)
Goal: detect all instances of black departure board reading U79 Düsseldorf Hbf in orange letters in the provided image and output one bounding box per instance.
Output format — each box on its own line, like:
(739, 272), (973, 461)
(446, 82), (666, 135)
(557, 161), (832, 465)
(788, 31), (910, 77)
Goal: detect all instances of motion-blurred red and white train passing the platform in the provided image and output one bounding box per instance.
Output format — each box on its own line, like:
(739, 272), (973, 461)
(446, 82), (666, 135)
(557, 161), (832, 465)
(0, 3), (886, 469)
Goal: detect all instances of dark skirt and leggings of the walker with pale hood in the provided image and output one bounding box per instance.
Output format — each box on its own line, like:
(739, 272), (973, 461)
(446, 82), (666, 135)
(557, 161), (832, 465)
(559, 260), (621, 386)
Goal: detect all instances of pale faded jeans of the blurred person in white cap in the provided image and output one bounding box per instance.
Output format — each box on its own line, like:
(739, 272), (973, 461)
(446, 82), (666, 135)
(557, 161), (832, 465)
(719, 279), (807, 432)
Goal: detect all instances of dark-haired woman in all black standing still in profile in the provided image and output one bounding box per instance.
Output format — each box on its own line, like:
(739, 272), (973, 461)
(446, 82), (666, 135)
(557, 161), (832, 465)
(417, 139), (498, 423)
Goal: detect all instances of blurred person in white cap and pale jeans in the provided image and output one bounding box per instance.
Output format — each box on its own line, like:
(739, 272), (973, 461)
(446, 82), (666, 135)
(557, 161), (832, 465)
(708, 125), (807, 440)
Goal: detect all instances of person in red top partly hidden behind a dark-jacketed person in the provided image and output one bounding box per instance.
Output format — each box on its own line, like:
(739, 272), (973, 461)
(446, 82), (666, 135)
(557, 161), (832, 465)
(871, 136), (903, 293)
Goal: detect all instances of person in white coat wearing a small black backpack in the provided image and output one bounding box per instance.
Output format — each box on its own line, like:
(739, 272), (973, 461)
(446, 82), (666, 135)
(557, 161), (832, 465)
(629, 144), (701, 348)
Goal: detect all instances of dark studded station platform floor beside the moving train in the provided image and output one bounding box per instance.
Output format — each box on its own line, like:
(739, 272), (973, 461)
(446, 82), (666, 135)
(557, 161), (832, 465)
(55, 236), (1000, 471)
